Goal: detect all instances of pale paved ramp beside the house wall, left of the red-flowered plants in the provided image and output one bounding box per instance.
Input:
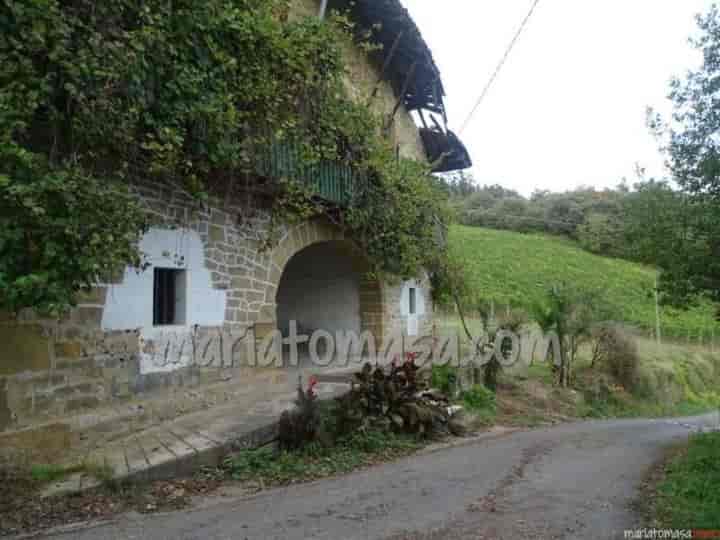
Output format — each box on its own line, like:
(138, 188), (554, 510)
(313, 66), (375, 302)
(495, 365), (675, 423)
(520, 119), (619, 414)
(40, 371), (347, 495)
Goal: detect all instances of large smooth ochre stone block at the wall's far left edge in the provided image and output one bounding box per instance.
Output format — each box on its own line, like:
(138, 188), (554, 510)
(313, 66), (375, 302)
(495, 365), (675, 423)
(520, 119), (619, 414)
(0, 325), (51, 376)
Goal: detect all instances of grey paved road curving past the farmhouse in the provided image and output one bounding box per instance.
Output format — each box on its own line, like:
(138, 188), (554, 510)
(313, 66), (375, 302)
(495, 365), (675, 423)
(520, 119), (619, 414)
(35, 414), (718, 540)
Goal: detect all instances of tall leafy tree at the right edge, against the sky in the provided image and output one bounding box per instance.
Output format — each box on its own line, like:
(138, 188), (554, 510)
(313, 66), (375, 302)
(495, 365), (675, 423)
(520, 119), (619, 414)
(649, 5), (720, 303)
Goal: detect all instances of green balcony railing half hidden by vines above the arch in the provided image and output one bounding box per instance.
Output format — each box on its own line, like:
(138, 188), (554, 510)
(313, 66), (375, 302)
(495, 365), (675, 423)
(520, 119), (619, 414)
(256, 141), (365, 206)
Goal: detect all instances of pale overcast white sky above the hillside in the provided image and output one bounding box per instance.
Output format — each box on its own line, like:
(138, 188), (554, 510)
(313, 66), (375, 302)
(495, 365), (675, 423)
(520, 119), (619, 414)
(403, 0), (712, 195)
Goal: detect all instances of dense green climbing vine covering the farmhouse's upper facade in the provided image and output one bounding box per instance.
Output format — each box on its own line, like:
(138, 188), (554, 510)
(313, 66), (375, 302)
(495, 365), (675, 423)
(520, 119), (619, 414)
(0, 0), (444, 312)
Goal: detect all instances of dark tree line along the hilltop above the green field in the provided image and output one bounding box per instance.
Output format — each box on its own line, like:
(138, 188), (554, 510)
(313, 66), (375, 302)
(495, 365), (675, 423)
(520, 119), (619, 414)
(444, 172), (686, 264)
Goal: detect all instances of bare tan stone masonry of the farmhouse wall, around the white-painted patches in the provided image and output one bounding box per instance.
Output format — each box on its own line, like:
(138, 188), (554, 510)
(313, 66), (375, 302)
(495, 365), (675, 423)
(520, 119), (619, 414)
(0, 0), (432, 460)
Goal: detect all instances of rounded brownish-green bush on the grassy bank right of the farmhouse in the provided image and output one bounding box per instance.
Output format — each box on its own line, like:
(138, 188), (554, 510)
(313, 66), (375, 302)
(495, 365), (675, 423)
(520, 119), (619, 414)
(593, 326), (640, 391)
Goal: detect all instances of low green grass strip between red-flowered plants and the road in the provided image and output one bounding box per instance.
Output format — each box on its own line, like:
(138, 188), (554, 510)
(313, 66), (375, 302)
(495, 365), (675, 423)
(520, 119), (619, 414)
(225, 431), (423, 486)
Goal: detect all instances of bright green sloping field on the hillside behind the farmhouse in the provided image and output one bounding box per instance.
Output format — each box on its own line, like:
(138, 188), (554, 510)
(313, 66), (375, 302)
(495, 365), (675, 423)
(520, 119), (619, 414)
(450, 226), (720, 343)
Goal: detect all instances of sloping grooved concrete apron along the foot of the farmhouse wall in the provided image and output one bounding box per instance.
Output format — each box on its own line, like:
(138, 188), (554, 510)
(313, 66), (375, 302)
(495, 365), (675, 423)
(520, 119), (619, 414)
(38, 374), (349, 497)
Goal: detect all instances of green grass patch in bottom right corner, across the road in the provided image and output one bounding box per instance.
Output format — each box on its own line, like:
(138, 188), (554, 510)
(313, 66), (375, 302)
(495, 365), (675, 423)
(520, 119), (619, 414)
(656, 433), (720, 530)
